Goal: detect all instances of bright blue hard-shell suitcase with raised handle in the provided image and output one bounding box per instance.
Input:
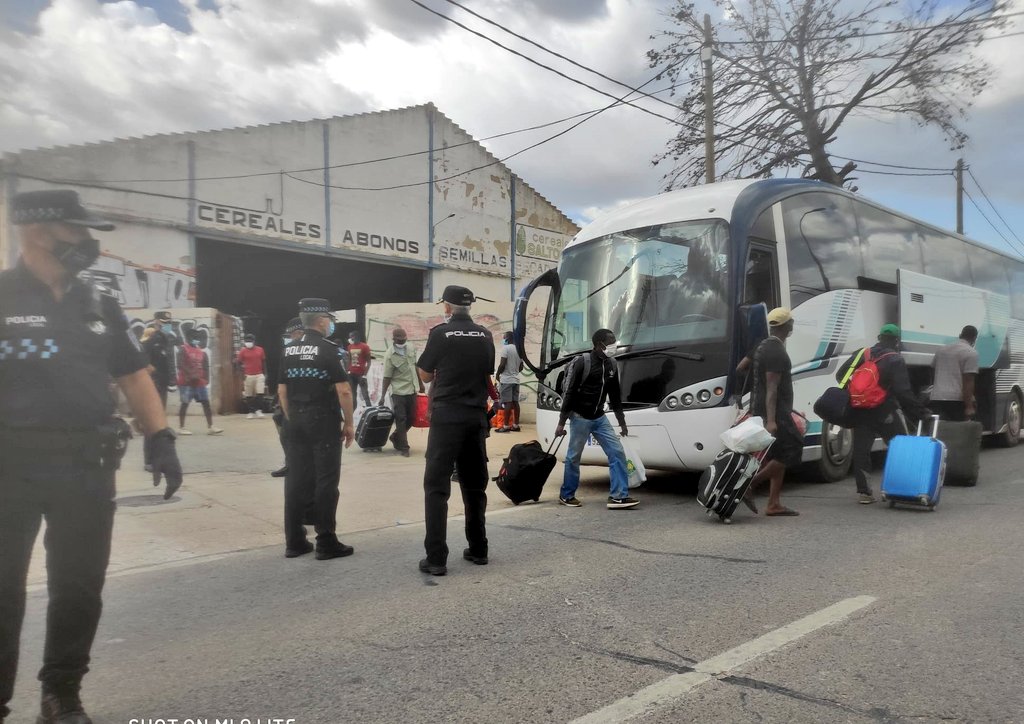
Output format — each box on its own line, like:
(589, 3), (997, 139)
(882, 415), (946, 510)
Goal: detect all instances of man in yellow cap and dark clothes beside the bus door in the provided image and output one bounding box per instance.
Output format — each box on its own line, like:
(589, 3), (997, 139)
(743, 307), (804, 516)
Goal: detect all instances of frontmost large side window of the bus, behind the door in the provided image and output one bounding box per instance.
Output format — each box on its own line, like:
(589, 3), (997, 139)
(782, 191), (863, 307)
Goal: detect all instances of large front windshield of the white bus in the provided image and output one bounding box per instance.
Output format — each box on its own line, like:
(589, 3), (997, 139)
(548, 219), (729, 359)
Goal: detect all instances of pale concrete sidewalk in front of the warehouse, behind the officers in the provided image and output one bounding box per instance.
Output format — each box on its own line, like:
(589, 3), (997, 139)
(29, 415), (585, 588)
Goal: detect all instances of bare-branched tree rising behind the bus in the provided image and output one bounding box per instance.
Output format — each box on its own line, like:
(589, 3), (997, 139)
(647, 0), (1006, 190)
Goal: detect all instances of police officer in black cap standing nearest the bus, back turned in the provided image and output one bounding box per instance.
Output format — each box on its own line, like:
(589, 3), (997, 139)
(417, 286), (495, 576)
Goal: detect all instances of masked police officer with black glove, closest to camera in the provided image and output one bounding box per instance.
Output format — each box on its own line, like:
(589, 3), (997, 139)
(0, 190), (181, 724)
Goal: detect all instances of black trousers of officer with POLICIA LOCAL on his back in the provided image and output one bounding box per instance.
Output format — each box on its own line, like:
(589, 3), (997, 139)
(285, 408), (341, 548)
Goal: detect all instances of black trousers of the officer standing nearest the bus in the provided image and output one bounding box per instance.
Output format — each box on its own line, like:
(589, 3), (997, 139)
(423, 419), (487, 565)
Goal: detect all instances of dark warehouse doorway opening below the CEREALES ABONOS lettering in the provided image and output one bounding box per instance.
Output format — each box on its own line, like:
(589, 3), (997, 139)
(196, 239), (423, 380)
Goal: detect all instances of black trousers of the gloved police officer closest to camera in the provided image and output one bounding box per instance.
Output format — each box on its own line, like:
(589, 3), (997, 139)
(0, 446), (115, 715)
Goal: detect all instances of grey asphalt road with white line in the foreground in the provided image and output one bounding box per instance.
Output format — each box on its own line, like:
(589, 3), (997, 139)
(8, 446), (1024, 724)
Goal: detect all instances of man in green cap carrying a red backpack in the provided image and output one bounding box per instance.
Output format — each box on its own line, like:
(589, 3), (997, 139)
(836, 324), (931, 505)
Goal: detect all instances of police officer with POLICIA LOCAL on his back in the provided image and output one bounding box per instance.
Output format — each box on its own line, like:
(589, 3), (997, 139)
(278, 299), (355, 560)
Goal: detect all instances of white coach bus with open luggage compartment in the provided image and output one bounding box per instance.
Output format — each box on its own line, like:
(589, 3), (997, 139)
(514, 179), (1024, 481)
